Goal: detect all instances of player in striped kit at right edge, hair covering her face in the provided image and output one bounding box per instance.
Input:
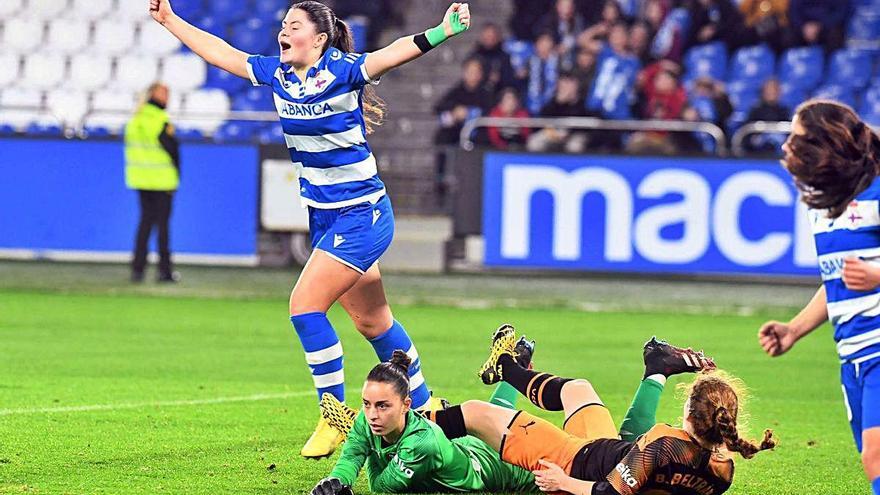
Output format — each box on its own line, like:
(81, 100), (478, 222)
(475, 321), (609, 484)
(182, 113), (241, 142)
(758, 100), (880, 495)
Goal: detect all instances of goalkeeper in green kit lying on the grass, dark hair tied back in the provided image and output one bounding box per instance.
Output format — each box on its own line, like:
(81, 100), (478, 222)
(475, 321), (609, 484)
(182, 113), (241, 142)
(311, 327), (714, 495)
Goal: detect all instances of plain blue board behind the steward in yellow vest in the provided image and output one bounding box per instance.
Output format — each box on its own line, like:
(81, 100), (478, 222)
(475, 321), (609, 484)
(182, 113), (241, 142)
(0, 139), (259, 265)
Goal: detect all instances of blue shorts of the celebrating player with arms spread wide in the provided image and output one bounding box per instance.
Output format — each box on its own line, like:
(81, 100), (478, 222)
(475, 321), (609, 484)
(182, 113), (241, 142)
(309, 196), (394, 273)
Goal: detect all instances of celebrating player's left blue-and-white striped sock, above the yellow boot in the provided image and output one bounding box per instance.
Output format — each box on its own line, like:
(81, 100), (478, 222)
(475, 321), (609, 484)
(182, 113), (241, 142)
(290, 312), (345, 402)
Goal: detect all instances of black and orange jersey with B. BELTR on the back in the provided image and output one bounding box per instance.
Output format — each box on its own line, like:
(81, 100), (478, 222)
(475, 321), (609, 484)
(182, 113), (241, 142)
(572, 424), (733, 495)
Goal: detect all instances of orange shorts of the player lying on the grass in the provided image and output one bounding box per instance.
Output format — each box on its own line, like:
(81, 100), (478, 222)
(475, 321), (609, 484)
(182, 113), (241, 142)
(500, 404), (618, 473)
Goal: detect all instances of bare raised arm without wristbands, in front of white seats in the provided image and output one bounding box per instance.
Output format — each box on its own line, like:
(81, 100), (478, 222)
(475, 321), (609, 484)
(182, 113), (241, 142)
(150, 0), (250, 79)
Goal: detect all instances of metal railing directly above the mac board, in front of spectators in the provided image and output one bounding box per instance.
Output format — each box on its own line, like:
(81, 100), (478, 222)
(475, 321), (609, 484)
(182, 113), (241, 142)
(459, 117), (727, 156)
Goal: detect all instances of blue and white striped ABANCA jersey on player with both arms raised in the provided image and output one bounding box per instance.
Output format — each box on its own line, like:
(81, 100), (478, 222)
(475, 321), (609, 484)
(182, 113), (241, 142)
(247, 48), (385, 209)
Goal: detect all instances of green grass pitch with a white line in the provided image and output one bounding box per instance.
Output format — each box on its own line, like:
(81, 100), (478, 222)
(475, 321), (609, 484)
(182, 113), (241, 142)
(0, 268), (869, 495)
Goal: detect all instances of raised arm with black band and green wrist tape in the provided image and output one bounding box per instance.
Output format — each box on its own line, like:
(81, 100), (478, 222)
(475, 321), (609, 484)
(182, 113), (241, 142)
(362, 0), (471, 79)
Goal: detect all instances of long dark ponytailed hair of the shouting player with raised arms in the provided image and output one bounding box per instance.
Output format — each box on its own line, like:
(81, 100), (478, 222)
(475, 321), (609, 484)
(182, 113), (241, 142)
(290, 0), (385, 134)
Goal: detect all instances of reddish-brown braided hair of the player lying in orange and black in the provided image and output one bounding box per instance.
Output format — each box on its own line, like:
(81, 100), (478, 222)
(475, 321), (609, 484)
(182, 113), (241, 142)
(688, 371), (776, 459)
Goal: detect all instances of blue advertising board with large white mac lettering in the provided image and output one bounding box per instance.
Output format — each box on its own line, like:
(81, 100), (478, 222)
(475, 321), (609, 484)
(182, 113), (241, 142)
(483, 153), (817, 276)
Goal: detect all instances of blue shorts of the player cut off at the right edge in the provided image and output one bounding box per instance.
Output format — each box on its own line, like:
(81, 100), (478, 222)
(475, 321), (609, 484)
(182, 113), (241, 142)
(840, 357), (880, 452)
